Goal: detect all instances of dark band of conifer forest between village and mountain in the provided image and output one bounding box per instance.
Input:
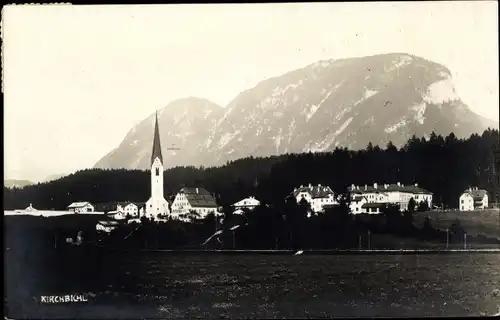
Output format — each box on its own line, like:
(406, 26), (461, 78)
(4, 129), (499, 210)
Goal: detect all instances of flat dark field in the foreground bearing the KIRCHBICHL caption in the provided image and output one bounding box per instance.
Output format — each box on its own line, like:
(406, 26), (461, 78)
(5, 252), (500, 319)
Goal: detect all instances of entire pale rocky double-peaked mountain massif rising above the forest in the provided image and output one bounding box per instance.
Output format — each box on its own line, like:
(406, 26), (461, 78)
(96, 53), (498, 168)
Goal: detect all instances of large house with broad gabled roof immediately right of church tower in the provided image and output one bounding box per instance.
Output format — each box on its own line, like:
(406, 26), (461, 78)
(172, 188), (217, 220)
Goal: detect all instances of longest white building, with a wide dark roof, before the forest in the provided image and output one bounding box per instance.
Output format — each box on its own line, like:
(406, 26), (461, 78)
(349, 182), (432, 214)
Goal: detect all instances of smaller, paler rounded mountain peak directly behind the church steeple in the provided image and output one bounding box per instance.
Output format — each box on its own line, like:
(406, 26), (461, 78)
(94, 97), (224, 169)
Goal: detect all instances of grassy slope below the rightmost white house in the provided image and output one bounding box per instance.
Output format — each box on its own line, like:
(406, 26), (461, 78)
(414, 209), (500, 239)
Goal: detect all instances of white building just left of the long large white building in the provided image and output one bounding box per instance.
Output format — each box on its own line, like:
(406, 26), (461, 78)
(289, 184), (338, 213)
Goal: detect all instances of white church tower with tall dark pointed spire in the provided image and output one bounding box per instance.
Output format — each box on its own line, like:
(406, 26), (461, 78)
(145, 113), (170, 218)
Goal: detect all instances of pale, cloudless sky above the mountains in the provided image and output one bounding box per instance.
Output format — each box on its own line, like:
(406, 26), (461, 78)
(2, 1), (499, 181)
